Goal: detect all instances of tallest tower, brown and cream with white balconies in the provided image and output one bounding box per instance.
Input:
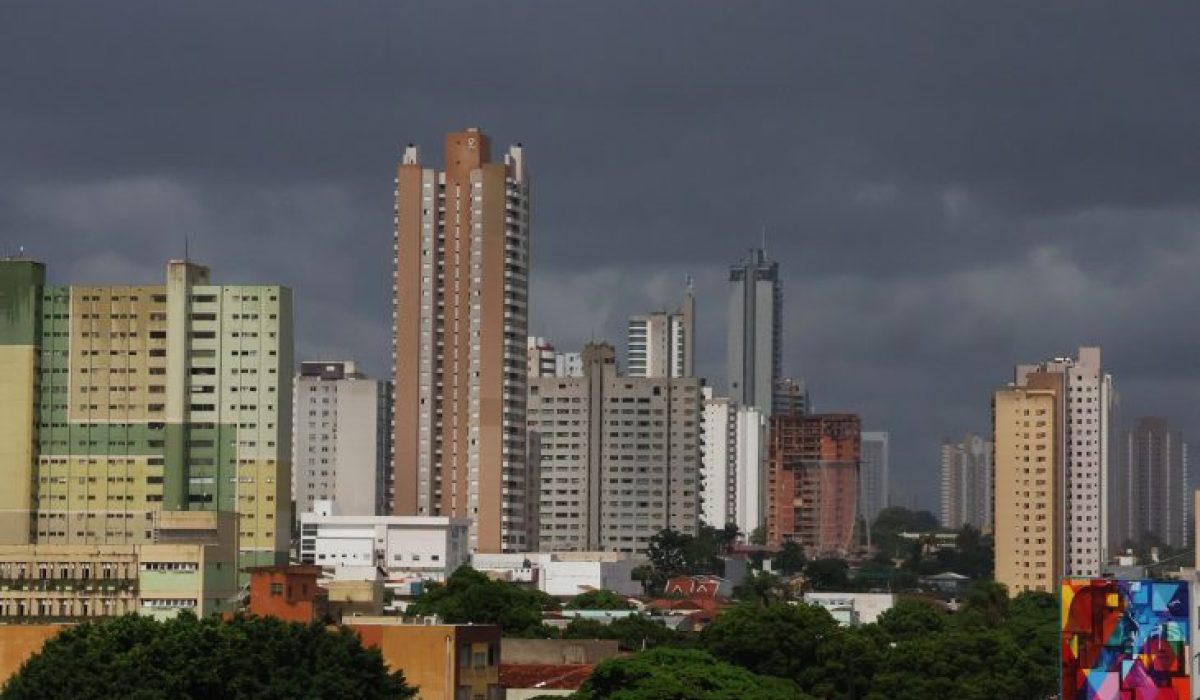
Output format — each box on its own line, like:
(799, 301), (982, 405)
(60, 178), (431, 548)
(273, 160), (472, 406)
(392, 128), (534, 552)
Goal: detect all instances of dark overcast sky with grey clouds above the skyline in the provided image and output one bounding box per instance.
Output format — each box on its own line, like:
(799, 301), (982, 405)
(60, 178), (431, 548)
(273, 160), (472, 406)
(0, 0), (1200, 509)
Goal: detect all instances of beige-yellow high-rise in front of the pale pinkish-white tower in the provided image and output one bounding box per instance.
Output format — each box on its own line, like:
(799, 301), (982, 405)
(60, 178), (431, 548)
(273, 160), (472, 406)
(992, 372), (1066, 596)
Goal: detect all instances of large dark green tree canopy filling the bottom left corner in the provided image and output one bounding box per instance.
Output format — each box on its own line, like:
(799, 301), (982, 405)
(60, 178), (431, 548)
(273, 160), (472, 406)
(2, 614), (416, 700)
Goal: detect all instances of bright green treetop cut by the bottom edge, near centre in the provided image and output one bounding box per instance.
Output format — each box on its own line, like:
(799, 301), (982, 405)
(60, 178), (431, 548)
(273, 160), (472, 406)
(572, 648), (810, 700)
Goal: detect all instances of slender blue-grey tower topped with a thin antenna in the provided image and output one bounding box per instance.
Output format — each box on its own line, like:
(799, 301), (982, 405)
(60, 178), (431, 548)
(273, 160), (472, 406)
(727, 249), (784, 415)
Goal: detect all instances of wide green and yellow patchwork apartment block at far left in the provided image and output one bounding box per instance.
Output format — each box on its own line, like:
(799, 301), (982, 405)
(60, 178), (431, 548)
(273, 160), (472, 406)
(0, 258), (292, 567)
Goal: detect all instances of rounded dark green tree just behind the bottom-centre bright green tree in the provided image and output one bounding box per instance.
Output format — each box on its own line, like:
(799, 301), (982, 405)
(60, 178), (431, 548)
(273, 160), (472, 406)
(701, 603), (838, 686)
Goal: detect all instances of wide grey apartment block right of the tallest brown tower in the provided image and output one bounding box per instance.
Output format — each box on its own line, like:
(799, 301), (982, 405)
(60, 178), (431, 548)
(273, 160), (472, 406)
(528, 343), (703, 555)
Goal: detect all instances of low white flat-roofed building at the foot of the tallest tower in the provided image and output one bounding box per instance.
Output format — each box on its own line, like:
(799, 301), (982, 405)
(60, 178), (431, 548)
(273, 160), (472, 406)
(300, 501), (470, 581)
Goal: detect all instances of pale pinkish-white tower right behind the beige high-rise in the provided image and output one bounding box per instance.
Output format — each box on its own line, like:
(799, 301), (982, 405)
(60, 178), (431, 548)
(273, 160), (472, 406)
(1012, 347), (1115, 578)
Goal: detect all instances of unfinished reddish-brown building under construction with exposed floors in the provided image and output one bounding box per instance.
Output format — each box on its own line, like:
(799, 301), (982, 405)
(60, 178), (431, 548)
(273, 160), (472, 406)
(767, 413), (860, 556)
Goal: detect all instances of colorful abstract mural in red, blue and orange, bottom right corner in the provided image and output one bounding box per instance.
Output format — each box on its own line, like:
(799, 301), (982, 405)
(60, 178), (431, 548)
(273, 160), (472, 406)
(1062, 579), (1192, 700)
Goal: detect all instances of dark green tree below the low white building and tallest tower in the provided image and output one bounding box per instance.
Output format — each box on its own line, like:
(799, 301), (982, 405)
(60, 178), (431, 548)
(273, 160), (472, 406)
(408, 567), (557, 636)
